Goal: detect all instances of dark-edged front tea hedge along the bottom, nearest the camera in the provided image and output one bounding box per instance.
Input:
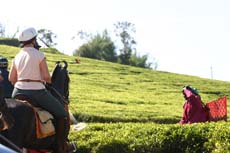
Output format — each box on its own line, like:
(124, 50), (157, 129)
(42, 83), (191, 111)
(69, 122), (230, 153)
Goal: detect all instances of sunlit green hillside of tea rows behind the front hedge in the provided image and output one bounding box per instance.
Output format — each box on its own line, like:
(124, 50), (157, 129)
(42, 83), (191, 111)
(0, 45), (230, 123)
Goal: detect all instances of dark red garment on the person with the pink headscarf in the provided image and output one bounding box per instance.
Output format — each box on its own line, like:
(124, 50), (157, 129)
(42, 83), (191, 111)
(179, 94), (208, 124)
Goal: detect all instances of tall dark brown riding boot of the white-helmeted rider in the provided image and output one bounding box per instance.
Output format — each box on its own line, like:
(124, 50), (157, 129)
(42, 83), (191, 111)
(56, 118), (68, 153)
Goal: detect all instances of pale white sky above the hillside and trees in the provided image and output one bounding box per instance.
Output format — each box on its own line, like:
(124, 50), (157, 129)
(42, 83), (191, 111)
(0, 0), (230, 81)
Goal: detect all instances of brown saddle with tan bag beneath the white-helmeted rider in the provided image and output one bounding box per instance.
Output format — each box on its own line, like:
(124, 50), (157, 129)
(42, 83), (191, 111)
(12, 95), (55, 139)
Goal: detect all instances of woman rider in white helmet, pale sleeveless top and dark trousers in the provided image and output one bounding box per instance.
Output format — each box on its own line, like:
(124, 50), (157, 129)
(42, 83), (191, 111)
(9, 28), (68, 153)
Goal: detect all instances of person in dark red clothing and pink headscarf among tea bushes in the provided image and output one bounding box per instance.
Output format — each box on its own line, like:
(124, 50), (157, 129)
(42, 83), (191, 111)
(179, 86), (208, 124)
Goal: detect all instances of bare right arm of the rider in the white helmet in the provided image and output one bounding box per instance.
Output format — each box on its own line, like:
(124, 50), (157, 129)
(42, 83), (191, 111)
(39, 58), (51, 83)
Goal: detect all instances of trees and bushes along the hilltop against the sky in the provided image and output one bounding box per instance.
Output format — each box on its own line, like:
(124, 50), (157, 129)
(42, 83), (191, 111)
(0, 21), (158, 69)
